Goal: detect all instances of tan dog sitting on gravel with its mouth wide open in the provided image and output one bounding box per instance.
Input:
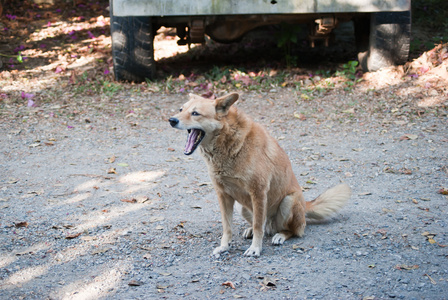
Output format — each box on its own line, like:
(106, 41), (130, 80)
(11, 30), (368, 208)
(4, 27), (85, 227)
(169, 93), (351, 256)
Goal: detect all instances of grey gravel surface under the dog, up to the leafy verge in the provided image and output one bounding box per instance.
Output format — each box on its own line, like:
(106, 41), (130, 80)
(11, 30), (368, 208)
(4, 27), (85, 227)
(0, 79), (448, 299)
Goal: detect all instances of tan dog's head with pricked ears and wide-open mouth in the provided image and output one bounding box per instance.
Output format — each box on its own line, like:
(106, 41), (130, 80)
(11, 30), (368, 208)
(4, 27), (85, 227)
(169, 93), (238, 155)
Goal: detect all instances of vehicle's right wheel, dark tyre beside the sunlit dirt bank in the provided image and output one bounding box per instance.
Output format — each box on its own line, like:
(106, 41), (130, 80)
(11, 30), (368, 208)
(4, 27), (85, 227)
(355, 11), (411, 71)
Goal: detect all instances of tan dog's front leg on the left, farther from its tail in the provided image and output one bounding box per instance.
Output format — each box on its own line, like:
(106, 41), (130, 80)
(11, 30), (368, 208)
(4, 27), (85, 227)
(213, 193), (235, 255)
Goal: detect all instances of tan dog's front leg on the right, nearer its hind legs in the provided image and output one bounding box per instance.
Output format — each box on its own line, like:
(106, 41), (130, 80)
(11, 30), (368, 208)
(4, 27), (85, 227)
(244, 189), (267, 256)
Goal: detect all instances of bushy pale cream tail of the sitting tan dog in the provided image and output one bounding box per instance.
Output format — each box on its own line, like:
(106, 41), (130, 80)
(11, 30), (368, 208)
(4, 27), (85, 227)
(306, 183), (352, 219)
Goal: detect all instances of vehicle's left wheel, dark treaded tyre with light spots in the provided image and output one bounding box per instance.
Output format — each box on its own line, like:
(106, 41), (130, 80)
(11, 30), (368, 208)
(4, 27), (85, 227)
(110, 1), (156, 82)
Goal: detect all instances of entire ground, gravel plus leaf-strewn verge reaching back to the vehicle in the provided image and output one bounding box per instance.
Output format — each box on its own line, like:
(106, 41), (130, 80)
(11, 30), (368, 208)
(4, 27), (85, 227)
(0, 1), (448, 300)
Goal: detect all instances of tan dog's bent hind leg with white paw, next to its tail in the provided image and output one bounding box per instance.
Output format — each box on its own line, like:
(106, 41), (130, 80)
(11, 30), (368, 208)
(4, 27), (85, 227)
(272, 193), (306, 245)
